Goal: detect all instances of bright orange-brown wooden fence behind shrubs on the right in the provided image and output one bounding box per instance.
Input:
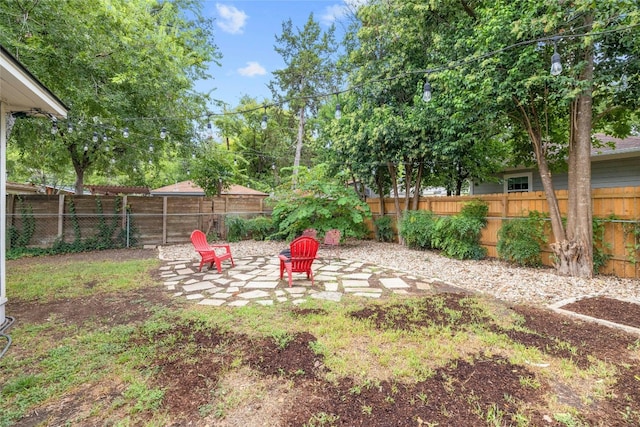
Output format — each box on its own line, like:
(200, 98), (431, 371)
(367, 187), (640, 278)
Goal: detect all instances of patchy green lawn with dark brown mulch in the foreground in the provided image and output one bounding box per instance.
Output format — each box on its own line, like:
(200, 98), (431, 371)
(0, 250), (640, 426)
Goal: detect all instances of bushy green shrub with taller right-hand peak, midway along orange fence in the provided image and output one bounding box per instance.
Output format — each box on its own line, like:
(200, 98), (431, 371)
(433, 201), (489, 259)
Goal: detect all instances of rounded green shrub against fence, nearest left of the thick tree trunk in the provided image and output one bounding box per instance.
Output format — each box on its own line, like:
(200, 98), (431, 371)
(496, 211), (547, 267)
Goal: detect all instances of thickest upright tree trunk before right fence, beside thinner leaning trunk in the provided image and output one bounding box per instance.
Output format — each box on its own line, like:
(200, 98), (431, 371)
(551, 32), (593, 278)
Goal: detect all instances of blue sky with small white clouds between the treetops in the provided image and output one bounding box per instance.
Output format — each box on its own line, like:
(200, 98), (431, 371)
(196, 0), (353, 113)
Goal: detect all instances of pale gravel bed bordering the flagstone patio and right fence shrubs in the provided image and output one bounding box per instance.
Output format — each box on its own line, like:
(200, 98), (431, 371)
(160, 240), (640, 305)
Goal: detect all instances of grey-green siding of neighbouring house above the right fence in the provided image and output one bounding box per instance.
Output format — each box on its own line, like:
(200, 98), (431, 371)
(473, 157), (640, 194)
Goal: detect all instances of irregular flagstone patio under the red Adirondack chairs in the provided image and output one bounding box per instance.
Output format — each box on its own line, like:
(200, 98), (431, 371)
(160, 256), (456, 307)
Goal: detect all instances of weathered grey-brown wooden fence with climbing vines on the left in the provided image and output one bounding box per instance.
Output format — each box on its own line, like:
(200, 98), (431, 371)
(7, 195), (265, 248)
